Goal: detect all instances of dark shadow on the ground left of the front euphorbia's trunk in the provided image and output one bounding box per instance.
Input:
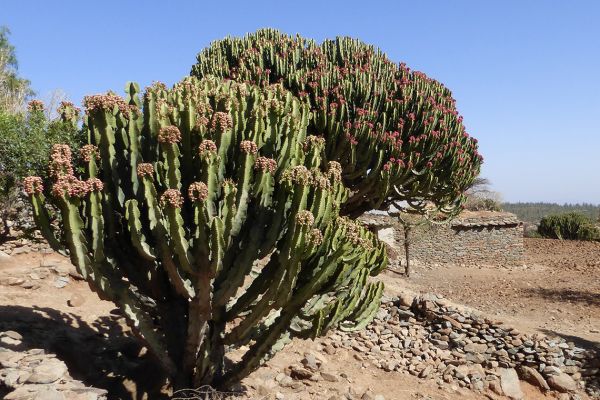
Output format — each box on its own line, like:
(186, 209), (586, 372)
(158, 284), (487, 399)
(0, 306), (168, 400)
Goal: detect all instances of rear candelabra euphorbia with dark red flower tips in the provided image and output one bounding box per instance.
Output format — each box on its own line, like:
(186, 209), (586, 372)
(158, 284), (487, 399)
(192, 29), (482, 216)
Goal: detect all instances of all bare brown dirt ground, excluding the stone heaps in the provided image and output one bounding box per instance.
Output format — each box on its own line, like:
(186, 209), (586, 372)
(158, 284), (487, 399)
(0, 239), (600, 400)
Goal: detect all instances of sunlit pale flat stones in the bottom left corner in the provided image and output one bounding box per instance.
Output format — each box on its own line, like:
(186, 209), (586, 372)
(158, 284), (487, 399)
(0, 331), (107, 400)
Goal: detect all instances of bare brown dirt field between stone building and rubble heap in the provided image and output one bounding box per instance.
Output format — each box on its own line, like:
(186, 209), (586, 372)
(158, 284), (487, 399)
(388, 239), (600, 345)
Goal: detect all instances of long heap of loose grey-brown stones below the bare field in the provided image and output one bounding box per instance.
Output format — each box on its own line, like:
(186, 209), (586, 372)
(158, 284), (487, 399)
(328, 295), (600, 399)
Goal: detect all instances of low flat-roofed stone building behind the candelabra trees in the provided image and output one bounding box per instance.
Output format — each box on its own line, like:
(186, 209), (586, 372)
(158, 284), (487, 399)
(361, 211), (524, 266)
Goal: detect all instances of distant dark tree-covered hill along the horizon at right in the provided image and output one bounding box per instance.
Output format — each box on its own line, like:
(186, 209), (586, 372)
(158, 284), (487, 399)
(502, 203), (600, 224)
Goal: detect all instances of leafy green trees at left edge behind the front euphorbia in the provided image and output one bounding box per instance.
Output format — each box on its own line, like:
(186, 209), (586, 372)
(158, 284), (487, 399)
(0, 27), (83, 241)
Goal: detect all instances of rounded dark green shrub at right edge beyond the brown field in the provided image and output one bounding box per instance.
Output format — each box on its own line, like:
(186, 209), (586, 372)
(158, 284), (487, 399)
(538, 212), (600, 240)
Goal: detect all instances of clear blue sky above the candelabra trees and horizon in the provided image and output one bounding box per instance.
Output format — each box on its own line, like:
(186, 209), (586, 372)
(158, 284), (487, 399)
(0, 0), (600, 203)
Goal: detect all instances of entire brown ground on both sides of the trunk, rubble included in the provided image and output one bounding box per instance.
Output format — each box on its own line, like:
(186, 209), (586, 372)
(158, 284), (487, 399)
(0, 240), (600, 400)
